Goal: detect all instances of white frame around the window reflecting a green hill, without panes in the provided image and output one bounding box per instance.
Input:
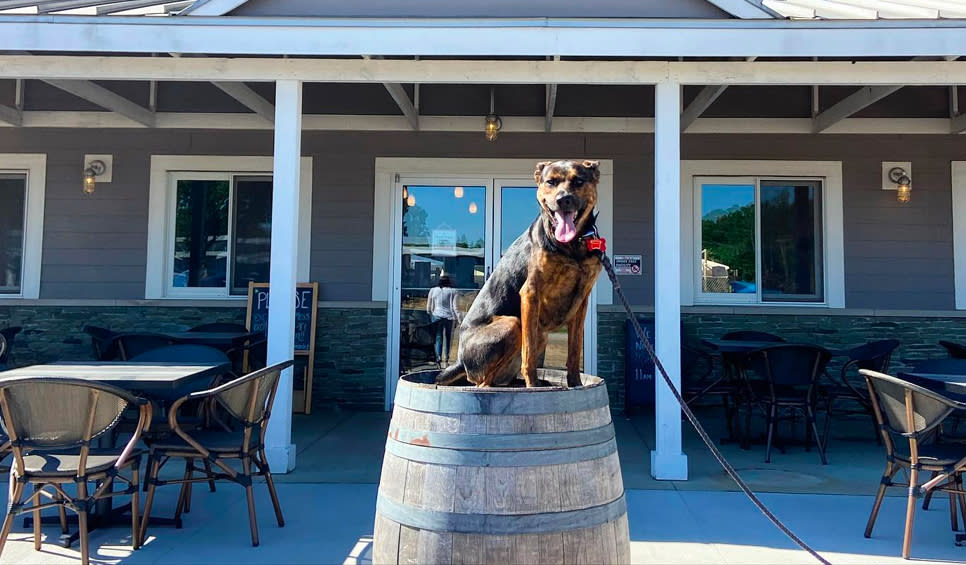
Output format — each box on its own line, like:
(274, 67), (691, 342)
(681, 160), (845, 308)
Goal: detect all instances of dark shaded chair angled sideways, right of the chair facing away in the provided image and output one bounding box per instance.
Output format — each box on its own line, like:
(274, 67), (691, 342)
(824, 339), (899, 447)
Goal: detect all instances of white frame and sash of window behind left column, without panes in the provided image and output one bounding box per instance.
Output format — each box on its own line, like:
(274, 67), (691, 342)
(144, 155), (312, 301)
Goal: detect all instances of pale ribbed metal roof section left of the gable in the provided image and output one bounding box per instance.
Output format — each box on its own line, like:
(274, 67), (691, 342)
(0, 0), (196, 16)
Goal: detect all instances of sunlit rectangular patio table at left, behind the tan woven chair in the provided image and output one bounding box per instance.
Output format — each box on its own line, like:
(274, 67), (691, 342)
(0, 361), (231, 547)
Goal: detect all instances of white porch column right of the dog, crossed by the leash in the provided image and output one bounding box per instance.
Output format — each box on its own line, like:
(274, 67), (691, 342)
(651, 82), (688, 480)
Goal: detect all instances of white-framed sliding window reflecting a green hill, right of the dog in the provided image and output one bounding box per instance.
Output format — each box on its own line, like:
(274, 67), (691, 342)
(682, 161), (844, 308)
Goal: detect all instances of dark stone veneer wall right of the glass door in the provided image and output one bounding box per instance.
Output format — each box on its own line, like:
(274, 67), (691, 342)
(597, 311), (966, 410)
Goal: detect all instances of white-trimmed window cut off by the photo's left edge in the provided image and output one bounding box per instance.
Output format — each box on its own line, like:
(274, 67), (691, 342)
(0, 154), (47, 298)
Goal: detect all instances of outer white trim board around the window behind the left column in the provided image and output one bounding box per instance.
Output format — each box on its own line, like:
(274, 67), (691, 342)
(144, 154), (312, 302)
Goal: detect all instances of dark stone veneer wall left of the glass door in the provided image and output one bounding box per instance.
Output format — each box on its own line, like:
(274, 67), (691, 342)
(0, 305), (394, 410)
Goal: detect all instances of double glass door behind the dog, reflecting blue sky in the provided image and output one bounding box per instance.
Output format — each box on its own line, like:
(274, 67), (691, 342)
(391, 177), (596, 384)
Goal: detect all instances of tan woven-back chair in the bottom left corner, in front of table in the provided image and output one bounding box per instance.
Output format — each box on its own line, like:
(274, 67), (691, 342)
(0, 377), (151, 565)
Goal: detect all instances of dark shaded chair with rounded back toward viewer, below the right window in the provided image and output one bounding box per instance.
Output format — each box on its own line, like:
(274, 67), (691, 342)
(744, 344), (831, 465)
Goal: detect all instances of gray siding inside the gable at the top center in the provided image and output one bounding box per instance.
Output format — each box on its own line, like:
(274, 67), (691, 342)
(231, 0), (731, 18)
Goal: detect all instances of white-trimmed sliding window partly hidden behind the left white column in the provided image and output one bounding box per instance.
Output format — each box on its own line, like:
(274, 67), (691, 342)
(145, 156), (312, 298)
